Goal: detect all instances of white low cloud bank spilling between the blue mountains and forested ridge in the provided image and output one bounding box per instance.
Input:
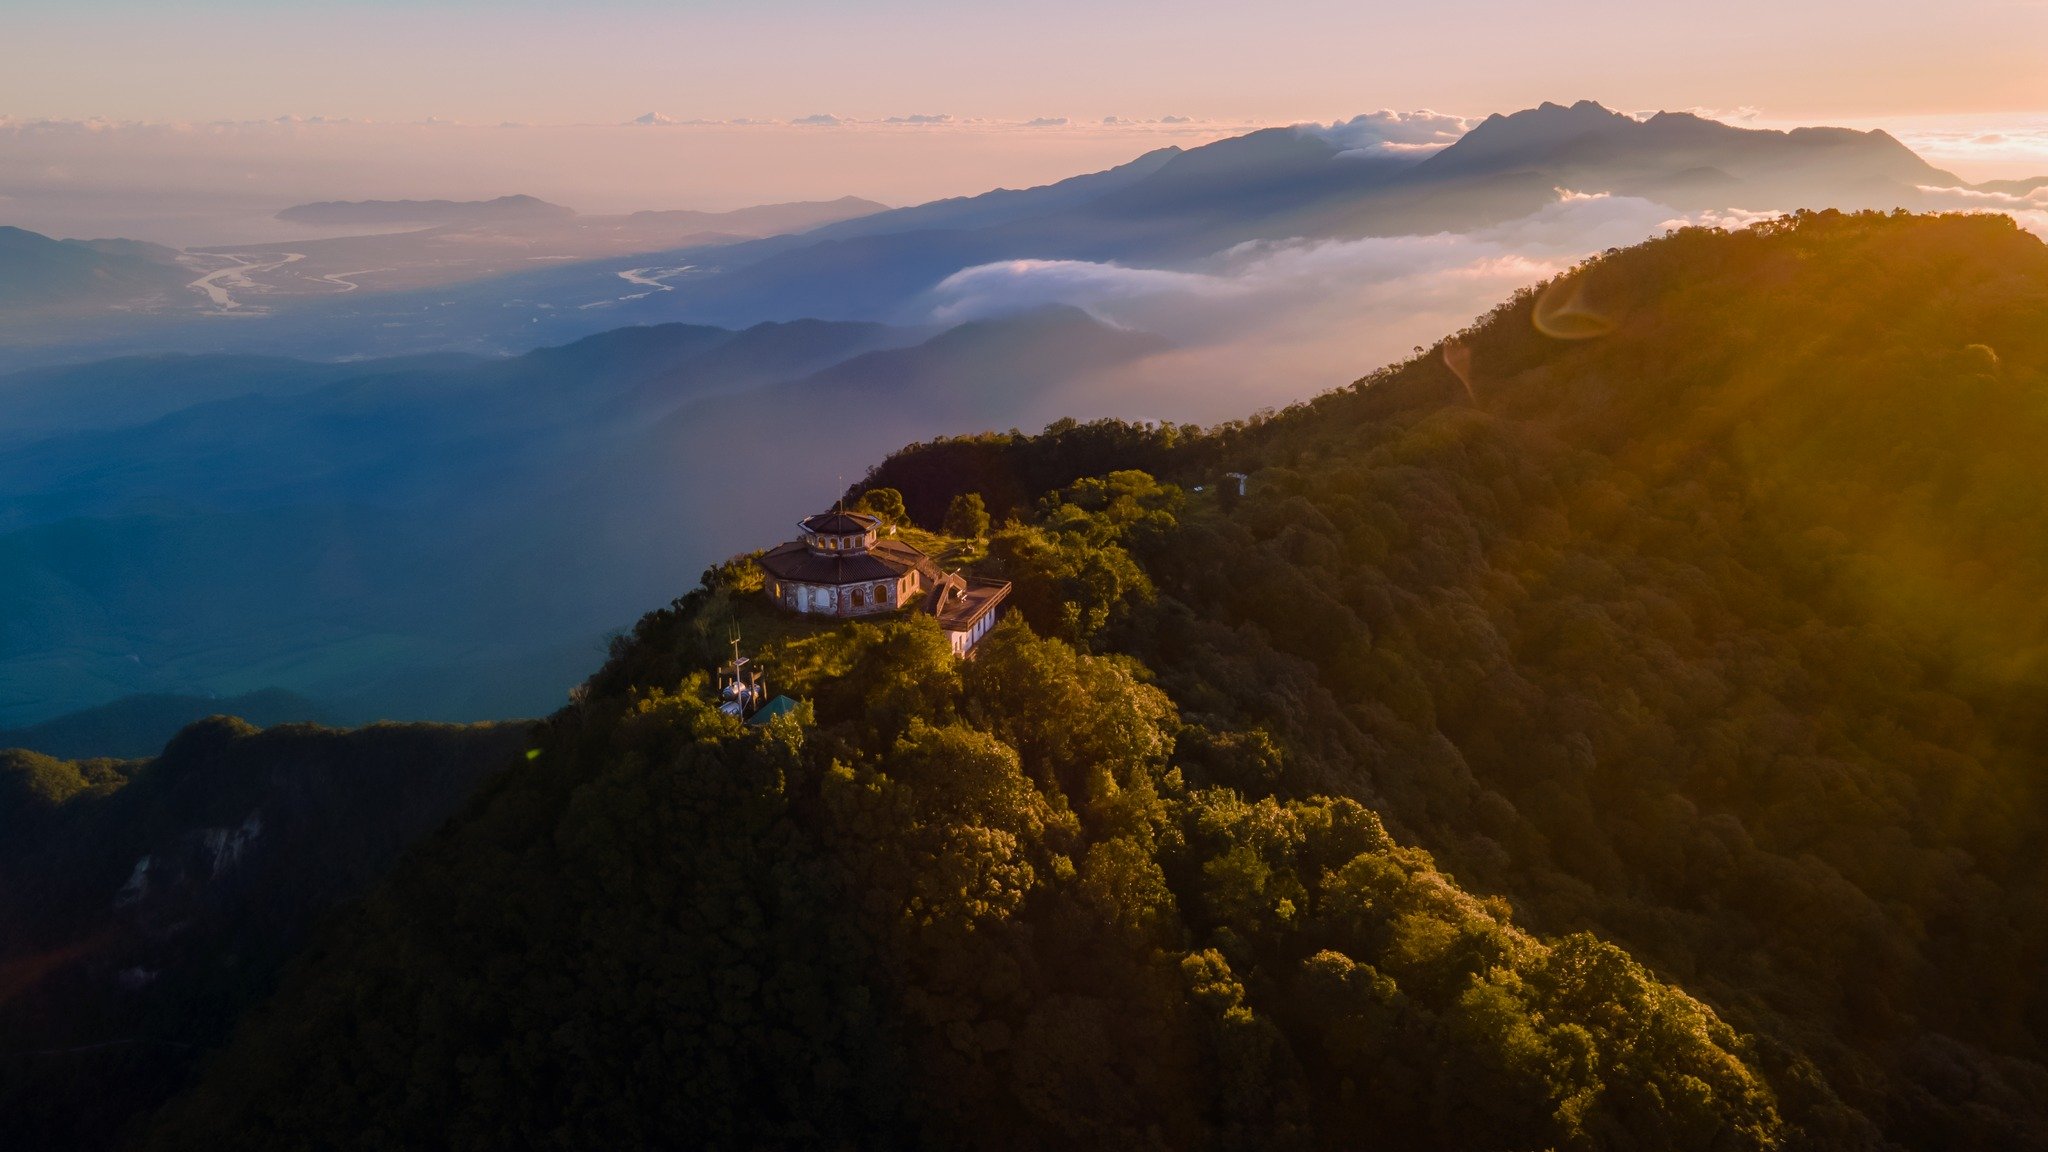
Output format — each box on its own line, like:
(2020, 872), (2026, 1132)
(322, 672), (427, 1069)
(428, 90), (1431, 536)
(932, 191), (1769, 420)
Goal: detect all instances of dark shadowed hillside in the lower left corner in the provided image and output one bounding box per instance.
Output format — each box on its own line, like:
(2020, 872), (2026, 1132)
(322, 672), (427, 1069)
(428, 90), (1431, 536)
(0, 715), (526, 1150)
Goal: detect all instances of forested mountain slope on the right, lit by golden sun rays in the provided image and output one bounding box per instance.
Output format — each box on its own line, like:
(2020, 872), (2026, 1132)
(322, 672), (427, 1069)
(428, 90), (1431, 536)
(872, 213), (2048, 1148)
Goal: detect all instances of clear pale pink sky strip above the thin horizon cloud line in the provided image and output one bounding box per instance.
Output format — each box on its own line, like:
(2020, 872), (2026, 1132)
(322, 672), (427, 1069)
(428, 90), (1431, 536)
(12, 0), (2048, 123)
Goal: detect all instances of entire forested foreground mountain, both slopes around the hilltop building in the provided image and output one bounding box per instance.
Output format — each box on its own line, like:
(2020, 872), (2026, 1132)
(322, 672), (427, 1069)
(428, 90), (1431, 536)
(28, 213), (2048, 1150)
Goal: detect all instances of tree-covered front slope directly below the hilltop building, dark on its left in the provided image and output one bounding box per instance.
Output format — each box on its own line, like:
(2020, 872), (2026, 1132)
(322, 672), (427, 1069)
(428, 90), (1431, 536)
(152, 565), (1780, 1148)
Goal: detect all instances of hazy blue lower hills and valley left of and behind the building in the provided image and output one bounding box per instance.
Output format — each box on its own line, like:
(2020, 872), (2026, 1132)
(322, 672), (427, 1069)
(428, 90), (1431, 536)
(0, 301), (1159, 721)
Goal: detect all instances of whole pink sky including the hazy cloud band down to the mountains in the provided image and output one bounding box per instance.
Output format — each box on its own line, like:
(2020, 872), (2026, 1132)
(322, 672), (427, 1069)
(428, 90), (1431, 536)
(0, 0), (2048, 244)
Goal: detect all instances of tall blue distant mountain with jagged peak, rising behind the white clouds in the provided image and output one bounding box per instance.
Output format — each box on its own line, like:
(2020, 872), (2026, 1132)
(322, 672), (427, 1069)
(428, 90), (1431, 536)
(552, 100), (1962, 324)
